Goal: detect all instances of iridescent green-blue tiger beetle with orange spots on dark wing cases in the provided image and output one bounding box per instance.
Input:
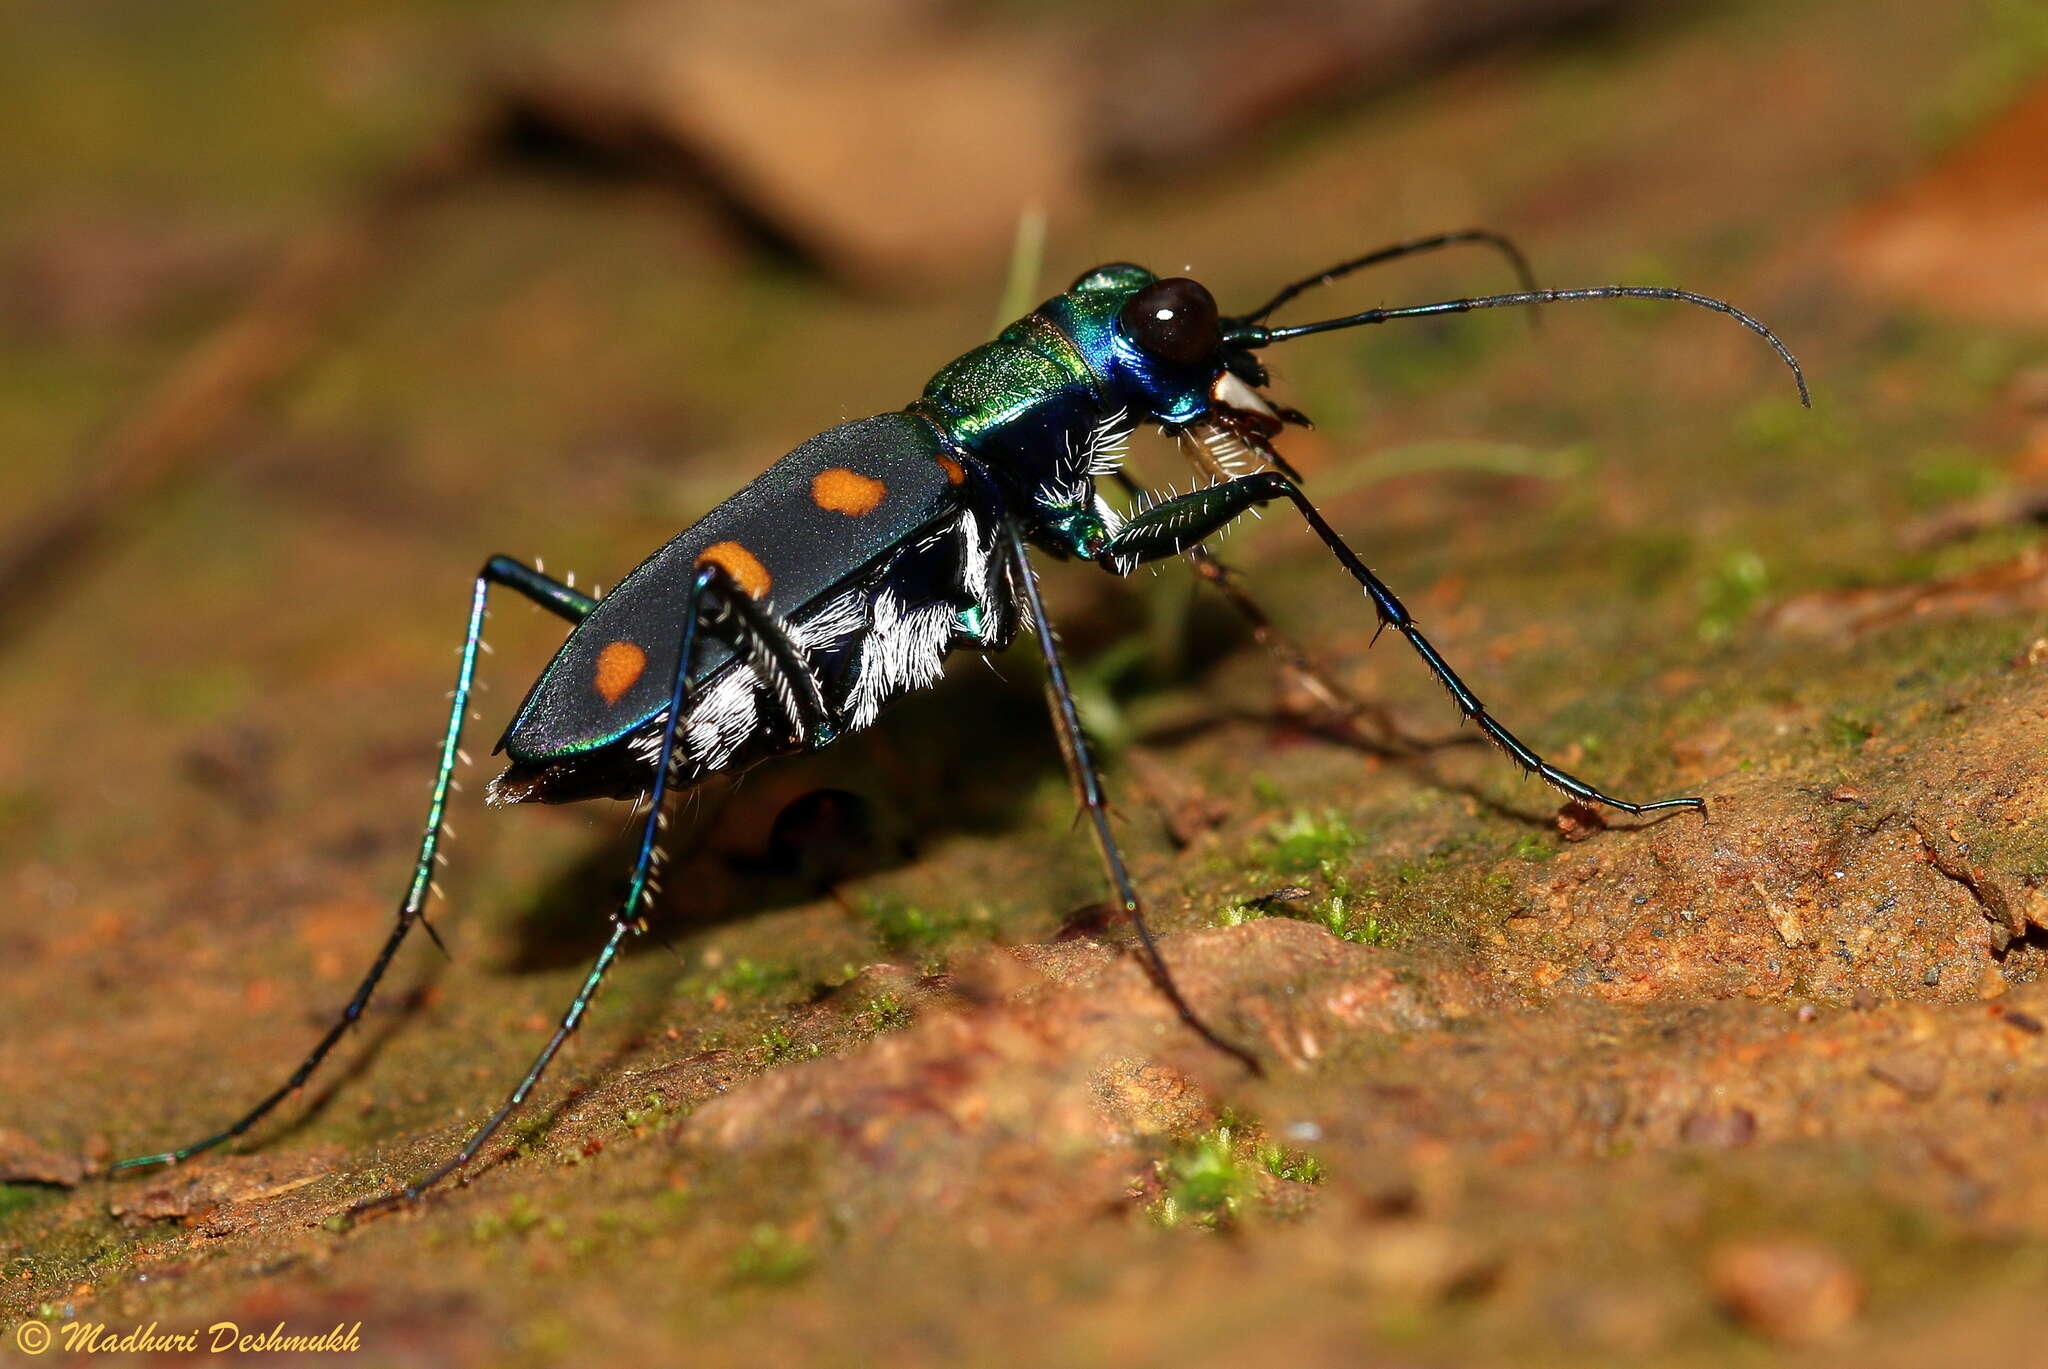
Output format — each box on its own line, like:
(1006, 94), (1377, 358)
(113, 230), (1808, 1209)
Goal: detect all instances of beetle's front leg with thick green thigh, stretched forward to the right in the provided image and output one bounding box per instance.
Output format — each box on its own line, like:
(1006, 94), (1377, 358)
(1096, 471), (1706, 814)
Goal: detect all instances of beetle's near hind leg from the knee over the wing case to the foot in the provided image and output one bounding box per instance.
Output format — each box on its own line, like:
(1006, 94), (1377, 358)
(350, 566), (733, 1213)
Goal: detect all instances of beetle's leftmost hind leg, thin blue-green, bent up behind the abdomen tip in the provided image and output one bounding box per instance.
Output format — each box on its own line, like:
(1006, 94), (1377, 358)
(109, 555), (598, 1172)
